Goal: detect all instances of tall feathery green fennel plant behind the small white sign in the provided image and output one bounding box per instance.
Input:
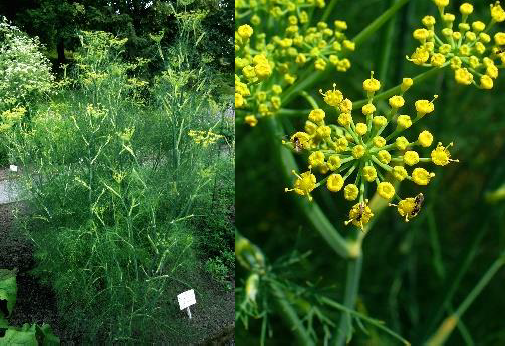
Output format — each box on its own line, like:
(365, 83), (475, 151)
(6, 27), (230, 343)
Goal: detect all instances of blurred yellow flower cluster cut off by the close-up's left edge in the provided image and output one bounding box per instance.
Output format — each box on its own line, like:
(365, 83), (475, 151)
(235, 0), (354, 126)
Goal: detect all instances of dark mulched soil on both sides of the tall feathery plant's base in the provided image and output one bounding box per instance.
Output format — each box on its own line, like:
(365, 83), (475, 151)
(0, 170), (235, 345)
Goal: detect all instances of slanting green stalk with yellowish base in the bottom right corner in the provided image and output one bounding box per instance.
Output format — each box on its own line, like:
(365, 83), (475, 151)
(426, 252), (505, 346)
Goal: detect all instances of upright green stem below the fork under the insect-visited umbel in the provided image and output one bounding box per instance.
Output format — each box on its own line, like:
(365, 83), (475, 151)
(334, 255), (363, 346)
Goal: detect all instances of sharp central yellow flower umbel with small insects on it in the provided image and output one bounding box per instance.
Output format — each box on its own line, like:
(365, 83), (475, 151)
(284, 73), (457, 228)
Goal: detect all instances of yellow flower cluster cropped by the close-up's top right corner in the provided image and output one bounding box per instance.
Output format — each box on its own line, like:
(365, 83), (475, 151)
(407, 0), (505, 89)
